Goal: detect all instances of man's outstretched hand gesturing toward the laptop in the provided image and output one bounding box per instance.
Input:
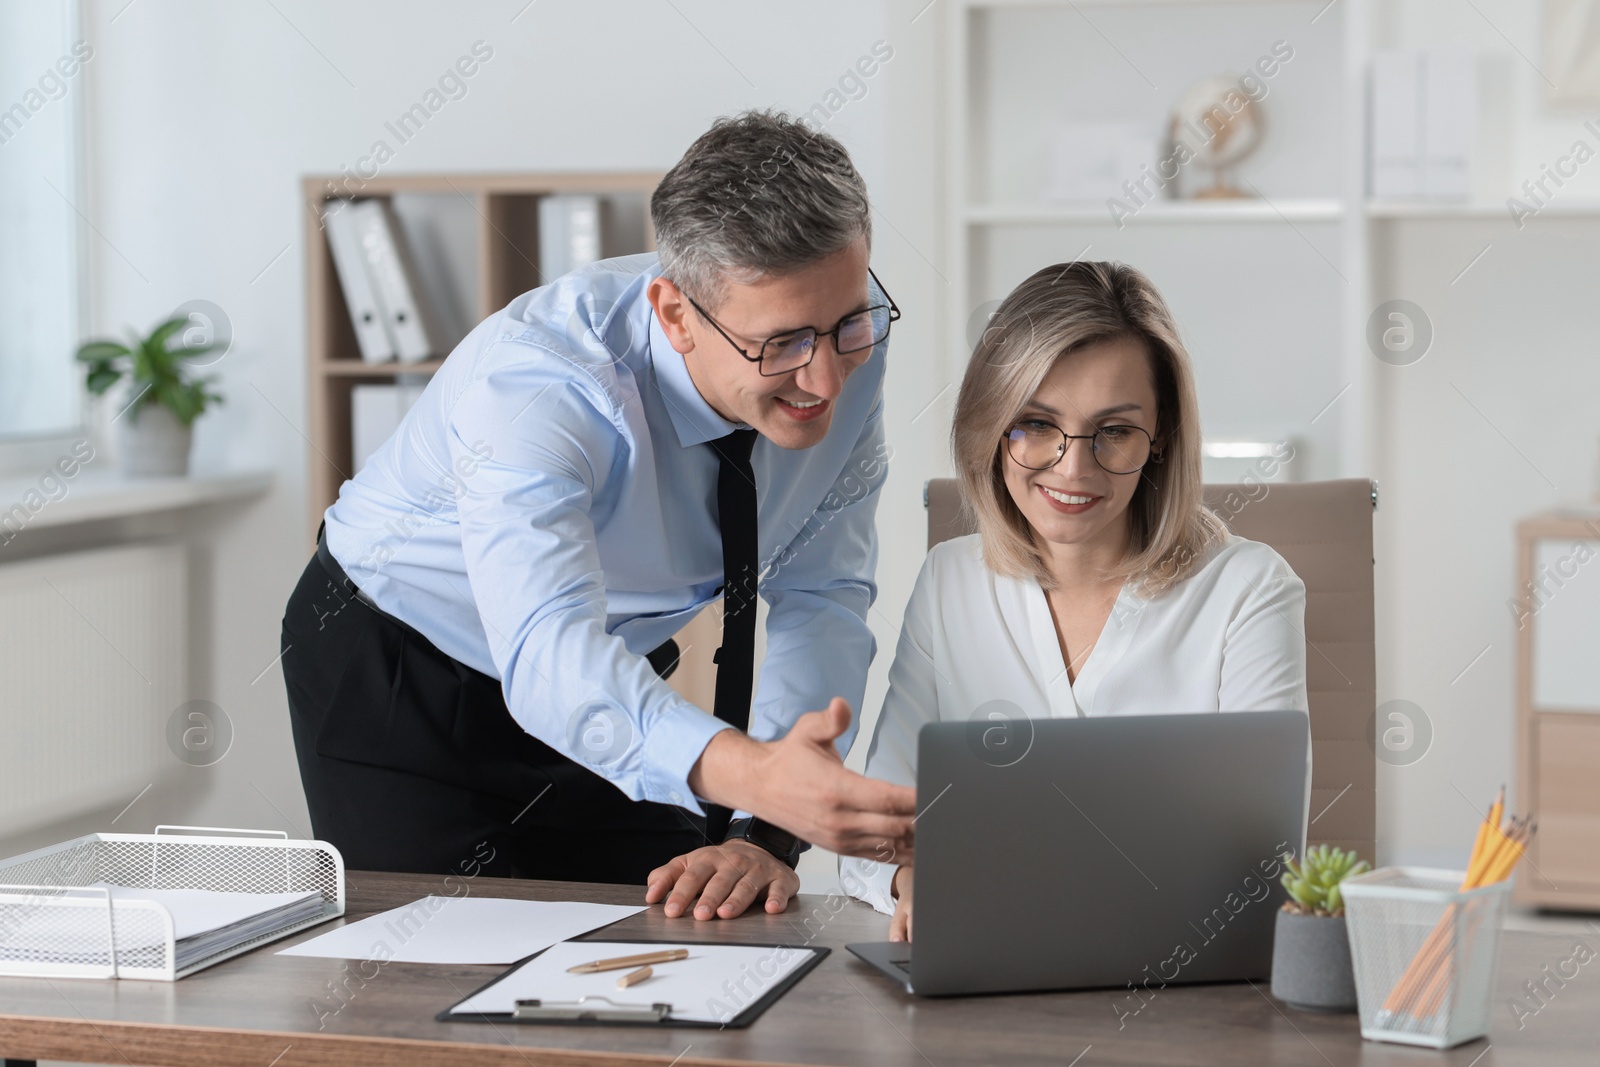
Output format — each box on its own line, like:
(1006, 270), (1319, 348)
(690, 697), (917, 862)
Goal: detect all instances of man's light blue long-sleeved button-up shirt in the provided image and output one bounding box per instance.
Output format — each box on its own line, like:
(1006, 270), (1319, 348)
(326, 254), (888, 811)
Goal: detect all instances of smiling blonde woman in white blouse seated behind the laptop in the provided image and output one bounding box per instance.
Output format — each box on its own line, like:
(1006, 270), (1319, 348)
(840, 262), (1307, 941)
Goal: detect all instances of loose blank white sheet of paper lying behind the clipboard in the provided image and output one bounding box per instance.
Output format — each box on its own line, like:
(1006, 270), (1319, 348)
(278, 896), (645, 963)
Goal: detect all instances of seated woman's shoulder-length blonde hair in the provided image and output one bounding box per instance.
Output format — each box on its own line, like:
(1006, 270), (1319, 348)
(950, 262), (1227, 597)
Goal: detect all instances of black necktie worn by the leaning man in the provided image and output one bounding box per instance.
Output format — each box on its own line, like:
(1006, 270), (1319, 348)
(706, 430), (760, 845)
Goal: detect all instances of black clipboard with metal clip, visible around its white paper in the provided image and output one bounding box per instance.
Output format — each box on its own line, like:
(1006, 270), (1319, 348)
(434, 937), (830, 1030)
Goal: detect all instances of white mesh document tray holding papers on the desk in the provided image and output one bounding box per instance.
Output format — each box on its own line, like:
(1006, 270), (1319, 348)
(0, 825), (344, 982)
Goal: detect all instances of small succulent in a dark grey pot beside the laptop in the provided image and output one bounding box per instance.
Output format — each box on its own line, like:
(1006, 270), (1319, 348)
(1272, 845), (1373, 1011)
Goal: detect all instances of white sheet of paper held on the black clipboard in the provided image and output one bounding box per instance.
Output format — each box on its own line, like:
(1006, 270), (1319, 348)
(451, 941), (813, 1022)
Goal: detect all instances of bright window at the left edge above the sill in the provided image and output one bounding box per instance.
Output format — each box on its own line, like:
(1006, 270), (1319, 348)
(0, 0), (85, 447)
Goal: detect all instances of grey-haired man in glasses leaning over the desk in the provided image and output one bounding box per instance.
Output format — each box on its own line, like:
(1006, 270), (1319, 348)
(283, 112), (914, 918)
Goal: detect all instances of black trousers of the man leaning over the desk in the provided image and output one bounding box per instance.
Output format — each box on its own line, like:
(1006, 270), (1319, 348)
(282, 543), (706, 885)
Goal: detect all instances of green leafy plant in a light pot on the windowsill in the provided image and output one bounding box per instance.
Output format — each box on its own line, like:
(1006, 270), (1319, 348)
(78, 310), (226, 477)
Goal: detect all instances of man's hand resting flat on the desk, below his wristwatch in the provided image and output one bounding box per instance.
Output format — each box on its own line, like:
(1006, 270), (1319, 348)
(645, 840), (800, 918)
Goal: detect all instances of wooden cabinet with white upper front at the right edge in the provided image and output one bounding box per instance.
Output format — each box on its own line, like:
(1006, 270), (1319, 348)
(1507, 514), (1600, 910)
